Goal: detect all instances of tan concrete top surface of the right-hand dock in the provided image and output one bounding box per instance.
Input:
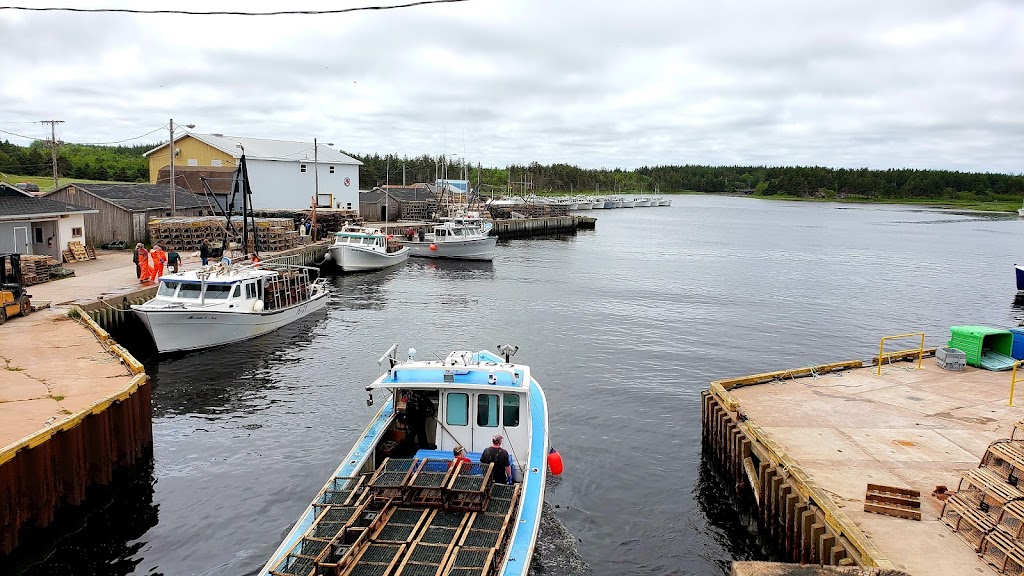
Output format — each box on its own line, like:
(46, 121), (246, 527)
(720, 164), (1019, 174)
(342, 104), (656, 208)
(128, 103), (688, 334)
(727, 359), (1024, 576)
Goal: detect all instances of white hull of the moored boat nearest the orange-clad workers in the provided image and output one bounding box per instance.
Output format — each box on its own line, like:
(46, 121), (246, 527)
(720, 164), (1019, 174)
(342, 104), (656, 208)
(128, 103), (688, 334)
(132, 291), (328, 354)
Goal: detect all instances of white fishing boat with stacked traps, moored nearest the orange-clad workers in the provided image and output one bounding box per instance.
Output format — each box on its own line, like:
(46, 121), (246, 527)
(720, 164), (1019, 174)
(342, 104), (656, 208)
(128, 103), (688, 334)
(131, 262), (328, 353)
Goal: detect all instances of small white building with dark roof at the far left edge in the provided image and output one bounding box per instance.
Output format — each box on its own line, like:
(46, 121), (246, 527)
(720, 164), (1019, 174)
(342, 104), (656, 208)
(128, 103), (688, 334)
(0, 182), (97, 256)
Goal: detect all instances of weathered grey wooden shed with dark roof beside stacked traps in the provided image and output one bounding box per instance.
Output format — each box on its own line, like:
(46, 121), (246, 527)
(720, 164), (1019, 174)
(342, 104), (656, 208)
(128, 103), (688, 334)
(44, 183), (213, 246)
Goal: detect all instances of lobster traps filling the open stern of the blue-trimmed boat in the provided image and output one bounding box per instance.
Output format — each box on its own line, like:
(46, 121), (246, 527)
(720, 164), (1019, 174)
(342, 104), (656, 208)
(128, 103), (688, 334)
(270, 458), (519, 576)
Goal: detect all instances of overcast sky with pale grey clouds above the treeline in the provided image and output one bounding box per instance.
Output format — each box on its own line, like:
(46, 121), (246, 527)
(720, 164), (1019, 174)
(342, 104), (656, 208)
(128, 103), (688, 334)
(0, 0), (1024, 173)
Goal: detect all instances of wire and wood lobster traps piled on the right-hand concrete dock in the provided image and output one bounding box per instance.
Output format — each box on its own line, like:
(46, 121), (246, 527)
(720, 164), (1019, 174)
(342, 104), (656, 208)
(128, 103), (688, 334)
(940, 420), (1024, 575)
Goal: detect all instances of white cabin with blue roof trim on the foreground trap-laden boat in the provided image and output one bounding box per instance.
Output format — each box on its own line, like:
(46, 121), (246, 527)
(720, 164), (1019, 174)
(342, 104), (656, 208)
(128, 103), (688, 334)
(367, 352), (530, 481)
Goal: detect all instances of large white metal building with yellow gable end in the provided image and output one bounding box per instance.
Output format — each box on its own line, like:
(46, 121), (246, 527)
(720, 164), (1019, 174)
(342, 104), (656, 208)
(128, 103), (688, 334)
(144, 132), (362, 210)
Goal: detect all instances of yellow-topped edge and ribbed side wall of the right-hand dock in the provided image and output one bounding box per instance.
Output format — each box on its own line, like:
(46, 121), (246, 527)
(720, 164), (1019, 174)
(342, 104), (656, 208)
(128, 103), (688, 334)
(700, 348), (935, 569)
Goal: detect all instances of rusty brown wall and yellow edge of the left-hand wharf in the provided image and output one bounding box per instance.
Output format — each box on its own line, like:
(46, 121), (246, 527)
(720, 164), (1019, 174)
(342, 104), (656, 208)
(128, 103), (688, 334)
(0, 306), (153, 554)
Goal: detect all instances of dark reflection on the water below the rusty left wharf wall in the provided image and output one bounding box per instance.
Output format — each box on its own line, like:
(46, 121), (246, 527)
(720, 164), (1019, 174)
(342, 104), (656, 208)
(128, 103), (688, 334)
(0, 451), (161, 576)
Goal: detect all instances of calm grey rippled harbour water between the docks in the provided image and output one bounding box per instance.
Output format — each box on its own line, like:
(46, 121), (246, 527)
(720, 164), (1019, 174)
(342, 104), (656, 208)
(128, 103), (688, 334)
(8, 196), (1024, 576)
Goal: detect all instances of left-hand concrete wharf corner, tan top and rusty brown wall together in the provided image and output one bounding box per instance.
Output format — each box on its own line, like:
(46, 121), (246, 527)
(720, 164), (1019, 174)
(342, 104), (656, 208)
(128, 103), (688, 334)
(0, 308), (153, 554)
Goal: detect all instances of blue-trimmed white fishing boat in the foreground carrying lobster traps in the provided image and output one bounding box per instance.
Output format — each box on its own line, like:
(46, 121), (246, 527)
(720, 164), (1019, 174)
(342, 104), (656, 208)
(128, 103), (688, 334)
(259, 344), (561, 576)
